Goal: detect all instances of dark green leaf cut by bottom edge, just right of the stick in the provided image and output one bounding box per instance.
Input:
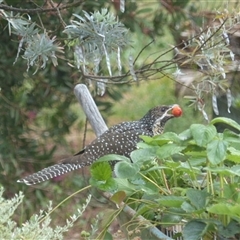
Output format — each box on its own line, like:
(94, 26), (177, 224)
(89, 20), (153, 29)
(183, 220), (207, 240)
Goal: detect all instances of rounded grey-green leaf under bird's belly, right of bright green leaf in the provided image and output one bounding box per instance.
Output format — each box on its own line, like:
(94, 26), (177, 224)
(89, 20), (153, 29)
(114, 162), (139, 178)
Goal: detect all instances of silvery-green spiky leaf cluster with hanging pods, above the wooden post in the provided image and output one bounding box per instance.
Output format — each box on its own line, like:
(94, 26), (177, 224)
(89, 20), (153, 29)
(64, 9), (129, 76)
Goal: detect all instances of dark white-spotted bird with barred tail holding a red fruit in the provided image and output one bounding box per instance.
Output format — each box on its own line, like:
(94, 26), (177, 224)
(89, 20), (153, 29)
(17, 104), (182, 185)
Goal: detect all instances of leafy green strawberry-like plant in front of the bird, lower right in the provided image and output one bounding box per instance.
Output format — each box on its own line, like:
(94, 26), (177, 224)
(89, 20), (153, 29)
(92, 117), (240, 240)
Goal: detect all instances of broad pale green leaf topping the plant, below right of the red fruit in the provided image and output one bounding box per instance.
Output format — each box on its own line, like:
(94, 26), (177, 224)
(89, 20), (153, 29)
(190, 124), (217, 147)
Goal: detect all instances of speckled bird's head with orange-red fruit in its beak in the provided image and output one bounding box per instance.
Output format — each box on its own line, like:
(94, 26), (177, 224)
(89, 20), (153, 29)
(143, 104), (182, 135)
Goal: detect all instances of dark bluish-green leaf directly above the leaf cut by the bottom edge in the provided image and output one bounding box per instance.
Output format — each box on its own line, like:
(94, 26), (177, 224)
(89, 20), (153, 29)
(186, 189), (209, 210)
